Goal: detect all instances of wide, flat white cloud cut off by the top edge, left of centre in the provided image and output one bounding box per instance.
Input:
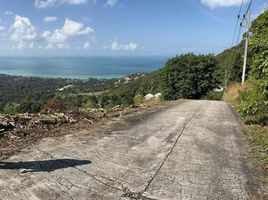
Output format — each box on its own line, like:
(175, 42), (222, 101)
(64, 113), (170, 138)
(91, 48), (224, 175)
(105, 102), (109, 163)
(34, 0), (87, 8)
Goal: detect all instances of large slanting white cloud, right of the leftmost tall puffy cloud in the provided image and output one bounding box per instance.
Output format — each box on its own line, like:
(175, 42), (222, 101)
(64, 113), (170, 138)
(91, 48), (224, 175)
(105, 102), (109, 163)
(42, 18), (94, 43)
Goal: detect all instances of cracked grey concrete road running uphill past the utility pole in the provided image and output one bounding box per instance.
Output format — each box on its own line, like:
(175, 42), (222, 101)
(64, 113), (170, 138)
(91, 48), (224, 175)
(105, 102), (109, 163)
(0, 101), (259, 200)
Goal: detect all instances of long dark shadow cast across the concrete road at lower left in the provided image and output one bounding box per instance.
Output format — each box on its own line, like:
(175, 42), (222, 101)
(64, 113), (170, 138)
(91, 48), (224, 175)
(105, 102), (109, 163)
(0, 159), (91, 173)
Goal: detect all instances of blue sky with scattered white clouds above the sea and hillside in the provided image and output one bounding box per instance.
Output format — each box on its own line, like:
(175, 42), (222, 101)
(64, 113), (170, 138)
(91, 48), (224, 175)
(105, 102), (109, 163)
(0, 0), (267, 56)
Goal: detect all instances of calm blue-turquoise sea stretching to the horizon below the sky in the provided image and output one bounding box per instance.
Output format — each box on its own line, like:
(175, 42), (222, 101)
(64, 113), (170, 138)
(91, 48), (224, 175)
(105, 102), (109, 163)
(0, 56), (168, 79)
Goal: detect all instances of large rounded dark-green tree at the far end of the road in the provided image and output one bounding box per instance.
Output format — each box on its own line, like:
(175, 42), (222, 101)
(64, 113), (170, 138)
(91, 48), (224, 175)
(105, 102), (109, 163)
(160, 54), (219, 100)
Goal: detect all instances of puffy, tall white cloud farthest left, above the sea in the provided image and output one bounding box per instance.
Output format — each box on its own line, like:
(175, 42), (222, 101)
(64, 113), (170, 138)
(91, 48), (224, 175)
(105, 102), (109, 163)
(11, 15), (37, 41)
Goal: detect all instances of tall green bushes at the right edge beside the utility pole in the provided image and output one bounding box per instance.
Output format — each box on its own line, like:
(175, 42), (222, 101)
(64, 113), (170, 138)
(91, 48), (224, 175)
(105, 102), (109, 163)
(237, 11), (268, 125)
